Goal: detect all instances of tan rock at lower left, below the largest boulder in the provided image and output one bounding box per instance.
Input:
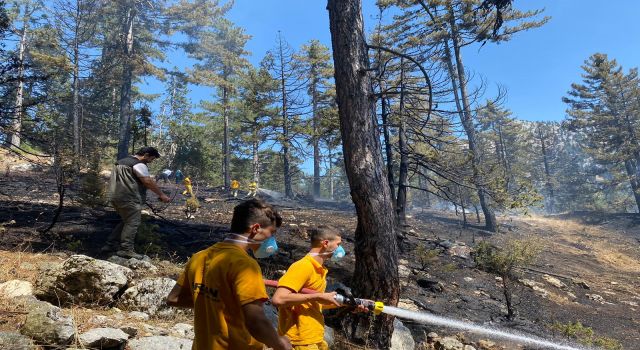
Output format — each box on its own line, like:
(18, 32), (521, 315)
(20, 298), (75, 345)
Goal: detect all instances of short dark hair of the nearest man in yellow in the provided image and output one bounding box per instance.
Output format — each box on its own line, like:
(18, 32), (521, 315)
(231, 198), (282, 233)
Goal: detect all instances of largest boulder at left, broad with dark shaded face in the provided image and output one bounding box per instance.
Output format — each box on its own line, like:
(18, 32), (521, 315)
(35, 255), (133, 304)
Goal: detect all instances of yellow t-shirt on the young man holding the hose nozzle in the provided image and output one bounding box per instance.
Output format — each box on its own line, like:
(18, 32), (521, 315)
(278, 255), (327, 345)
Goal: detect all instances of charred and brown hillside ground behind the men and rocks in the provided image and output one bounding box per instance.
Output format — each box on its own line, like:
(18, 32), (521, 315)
(0, 168), (640, 349)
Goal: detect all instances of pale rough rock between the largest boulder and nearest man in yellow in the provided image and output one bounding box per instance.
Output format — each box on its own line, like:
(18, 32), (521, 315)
(121, 277), (176, 315)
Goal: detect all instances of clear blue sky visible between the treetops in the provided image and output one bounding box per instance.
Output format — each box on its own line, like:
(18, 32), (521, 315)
(158, 0), (640, 120)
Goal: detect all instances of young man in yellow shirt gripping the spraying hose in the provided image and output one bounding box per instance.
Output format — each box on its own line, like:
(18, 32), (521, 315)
(271, 226), (345, 350)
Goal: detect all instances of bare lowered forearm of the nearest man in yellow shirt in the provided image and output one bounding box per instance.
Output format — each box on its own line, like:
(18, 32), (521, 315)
(242, 300), (292, 350)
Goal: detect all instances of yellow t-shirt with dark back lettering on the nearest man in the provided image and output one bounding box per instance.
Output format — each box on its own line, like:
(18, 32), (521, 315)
(178, 242), (268, 350)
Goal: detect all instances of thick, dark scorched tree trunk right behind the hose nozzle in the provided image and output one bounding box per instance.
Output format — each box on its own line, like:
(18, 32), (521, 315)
(327, 0), (400, 349)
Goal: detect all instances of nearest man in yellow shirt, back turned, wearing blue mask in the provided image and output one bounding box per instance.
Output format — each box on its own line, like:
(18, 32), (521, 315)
(167, 199), (291, 350)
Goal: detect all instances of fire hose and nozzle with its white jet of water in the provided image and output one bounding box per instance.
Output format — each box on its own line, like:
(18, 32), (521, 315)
(264, 280), (592, 350)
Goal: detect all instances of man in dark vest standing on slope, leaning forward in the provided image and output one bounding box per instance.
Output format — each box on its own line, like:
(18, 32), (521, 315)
(102, 147), (170, 259)
